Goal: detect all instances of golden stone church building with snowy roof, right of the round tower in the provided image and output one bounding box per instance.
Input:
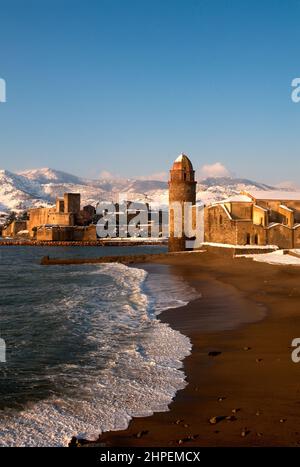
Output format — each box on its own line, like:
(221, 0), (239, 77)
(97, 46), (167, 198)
(204, 191), (300, 248)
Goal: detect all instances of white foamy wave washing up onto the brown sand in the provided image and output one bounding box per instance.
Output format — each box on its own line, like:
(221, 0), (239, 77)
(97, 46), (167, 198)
(0, 264), (196, 446)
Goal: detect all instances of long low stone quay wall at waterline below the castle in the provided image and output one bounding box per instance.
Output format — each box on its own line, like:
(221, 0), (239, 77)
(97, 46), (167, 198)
(0, 240), (168, 246)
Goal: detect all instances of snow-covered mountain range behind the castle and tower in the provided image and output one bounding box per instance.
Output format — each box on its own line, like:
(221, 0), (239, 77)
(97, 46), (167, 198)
(0, 168), (290, 219)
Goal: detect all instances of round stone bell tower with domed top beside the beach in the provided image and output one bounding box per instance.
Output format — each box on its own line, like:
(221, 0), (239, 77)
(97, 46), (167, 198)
(169, 154), (197, 251)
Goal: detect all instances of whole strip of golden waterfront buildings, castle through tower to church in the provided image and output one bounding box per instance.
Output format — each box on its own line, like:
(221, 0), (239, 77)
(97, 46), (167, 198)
(2, 153), (300, 257)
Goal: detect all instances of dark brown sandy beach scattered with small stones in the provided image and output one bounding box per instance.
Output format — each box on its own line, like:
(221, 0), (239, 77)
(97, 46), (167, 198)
(86, 252), (300, 446)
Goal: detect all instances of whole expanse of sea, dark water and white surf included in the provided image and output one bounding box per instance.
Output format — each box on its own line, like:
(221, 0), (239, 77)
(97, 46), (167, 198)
(0, 247), (197, 446)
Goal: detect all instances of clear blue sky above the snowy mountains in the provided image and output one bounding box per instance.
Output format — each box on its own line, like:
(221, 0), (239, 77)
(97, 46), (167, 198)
(0, 0), (300, 183)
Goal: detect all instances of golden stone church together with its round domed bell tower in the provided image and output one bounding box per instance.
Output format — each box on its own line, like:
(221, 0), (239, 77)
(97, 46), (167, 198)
(169, 154), (300, 251)
